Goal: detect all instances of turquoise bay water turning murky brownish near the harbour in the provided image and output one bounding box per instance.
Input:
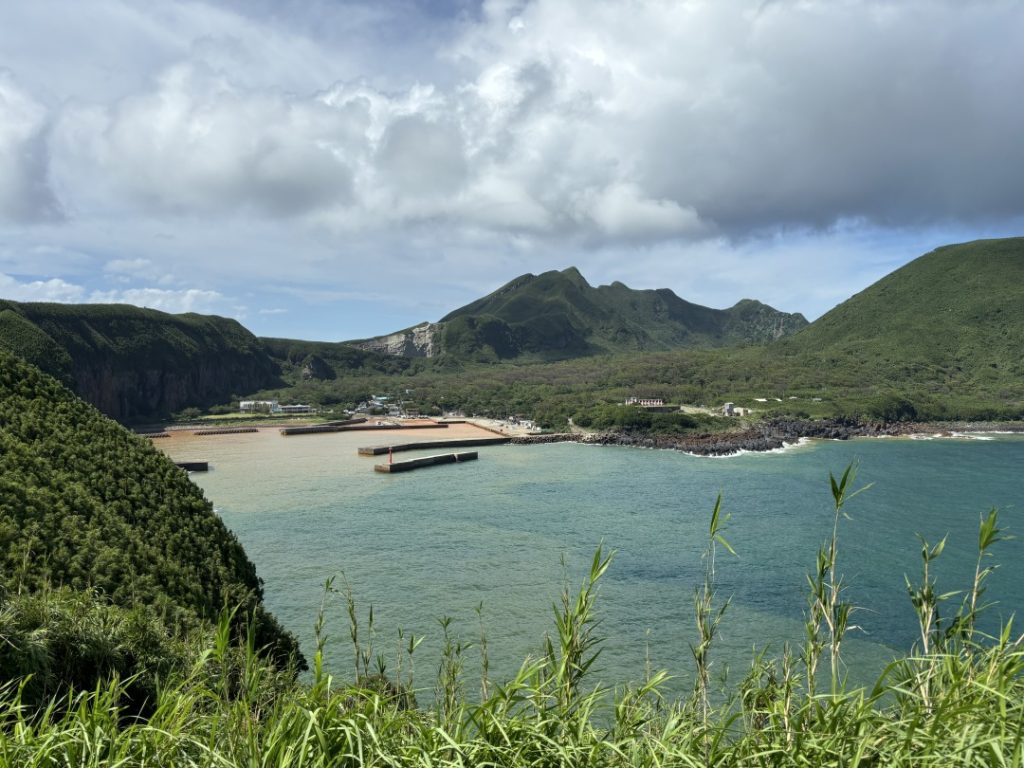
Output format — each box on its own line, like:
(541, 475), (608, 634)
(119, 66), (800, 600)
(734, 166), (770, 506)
(162, 431), (1024, 688)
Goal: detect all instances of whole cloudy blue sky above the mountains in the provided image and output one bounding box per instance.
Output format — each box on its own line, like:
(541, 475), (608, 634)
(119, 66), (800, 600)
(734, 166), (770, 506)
(0, 0), (1024, 341)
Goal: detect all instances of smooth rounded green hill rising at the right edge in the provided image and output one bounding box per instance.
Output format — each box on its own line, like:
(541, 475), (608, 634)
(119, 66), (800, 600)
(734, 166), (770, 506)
(774, 238), (1024, 400)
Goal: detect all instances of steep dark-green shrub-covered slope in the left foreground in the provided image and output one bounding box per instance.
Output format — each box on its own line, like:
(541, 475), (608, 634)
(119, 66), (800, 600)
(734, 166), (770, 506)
(0, 350), (297, 665)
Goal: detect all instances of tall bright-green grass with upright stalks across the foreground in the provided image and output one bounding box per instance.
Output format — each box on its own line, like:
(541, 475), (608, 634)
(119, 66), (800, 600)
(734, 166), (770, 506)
(0, 470), (1024, 768)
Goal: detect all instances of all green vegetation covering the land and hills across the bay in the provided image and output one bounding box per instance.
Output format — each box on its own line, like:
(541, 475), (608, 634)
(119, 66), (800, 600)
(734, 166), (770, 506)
(0, 238), (1024, 429)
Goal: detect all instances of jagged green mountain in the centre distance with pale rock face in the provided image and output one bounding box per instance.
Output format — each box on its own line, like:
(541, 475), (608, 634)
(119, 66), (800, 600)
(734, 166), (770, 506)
(349, 267), (807, 359)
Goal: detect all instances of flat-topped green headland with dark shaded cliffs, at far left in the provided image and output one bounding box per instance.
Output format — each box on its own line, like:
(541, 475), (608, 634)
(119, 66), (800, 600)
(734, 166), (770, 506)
(0, 300), (278, 423)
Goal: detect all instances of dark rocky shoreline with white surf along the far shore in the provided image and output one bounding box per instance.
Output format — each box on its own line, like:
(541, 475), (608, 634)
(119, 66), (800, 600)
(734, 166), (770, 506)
(511, 419), (1024, 456)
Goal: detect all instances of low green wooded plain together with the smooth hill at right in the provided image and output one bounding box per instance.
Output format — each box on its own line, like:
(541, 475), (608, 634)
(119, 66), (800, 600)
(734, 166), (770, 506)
(245, 238), (1024, 428)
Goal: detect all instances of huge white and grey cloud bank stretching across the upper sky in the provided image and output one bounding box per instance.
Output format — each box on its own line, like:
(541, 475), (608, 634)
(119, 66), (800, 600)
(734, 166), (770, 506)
(36, 0), (1024, 243)
